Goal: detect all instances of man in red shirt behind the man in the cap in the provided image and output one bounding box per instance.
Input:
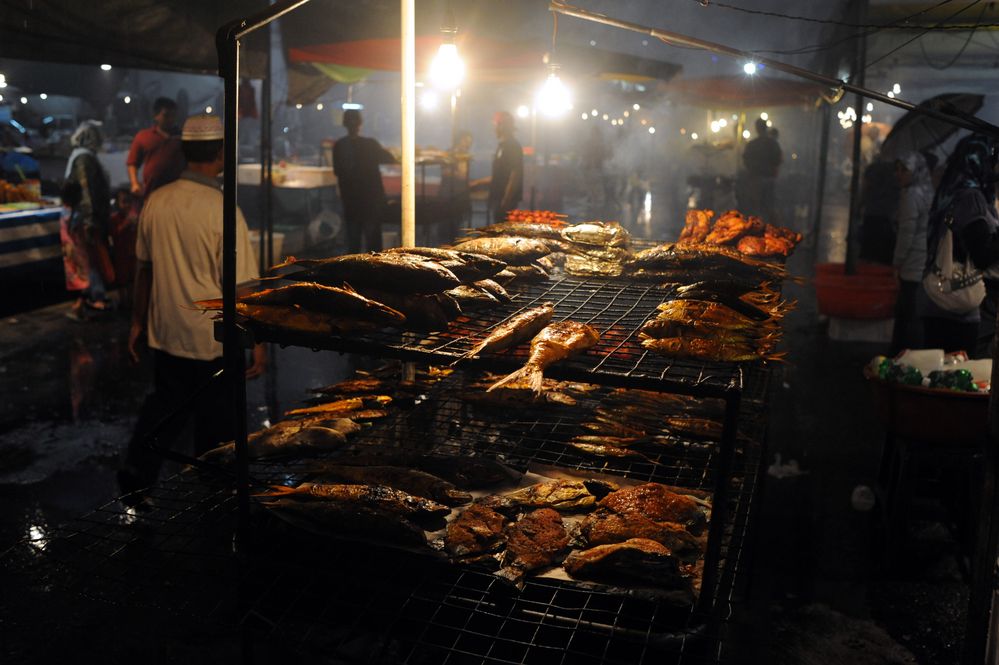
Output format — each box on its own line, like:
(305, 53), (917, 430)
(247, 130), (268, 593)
(126, 97), (185, 197)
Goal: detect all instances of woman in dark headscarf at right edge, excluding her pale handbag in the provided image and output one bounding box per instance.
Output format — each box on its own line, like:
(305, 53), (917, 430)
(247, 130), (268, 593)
(920, 134), (999, 358)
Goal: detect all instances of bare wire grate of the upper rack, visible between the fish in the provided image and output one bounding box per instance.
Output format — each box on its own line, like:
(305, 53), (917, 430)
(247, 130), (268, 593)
(238, 277), (746, 397)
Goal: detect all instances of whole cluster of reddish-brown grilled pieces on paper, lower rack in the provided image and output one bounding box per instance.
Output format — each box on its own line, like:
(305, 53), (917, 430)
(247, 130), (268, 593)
(445, 480), (707, 588)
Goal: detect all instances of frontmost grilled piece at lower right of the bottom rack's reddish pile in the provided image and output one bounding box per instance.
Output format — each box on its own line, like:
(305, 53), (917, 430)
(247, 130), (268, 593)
(565, 538), (685, 588)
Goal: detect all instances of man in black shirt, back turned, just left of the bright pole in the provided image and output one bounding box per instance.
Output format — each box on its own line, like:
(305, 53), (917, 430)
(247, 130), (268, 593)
(333, 109), (396, 254)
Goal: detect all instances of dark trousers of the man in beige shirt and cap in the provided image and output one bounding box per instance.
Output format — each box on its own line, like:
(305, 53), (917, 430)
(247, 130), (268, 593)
(124, 350), (235, 487)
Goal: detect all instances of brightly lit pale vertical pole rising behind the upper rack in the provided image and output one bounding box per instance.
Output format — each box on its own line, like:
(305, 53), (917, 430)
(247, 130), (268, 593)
(400, 0), (416, 247)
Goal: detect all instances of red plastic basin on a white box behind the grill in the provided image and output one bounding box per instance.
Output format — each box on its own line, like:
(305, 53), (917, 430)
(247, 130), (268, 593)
(815, 263), (898, 319)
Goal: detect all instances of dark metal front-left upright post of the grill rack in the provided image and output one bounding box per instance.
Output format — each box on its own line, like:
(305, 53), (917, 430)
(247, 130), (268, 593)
(221, 37), (252, 540)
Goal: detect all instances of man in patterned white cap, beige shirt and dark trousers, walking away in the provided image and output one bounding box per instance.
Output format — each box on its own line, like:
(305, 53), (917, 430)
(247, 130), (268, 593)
(118, 115), (266, 503)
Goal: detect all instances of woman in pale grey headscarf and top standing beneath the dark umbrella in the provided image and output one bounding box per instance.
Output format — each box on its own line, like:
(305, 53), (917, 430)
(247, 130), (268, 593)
(891, 152), (935, 354)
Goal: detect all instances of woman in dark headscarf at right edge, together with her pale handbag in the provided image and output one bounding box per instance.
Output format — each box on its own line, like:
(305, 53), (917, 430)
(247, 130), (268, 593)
(920, 134), (999, 358)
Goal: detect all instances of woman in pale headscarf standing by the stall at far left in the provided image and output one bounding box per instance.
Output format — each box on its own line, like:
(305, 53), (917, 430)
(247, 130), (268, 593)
(65, 121), (114, 315)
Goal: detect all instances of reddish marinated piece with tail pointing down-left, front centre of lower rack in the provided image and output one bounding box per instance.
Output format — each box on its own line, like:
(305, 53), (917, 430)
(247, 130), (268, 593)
(499, 508), (569, 583)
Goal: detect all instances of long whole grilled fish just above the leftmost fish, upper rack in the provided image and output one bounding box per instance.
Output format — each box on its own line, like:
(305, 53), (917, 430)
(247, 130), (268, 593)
(280, 252), (461, 293)
